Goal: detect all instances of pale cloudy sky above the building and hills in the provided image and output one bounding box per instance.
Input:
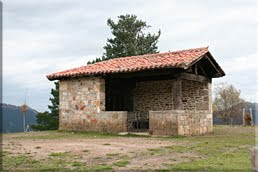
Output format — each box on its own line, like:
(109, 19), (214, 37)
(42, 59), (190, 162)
(2, 0), (258, 111)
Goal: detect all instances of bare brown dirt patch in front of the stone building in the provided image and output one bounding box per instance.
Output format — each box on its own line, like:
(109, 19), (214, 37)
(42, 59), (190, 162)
(3, 133), (201, 169)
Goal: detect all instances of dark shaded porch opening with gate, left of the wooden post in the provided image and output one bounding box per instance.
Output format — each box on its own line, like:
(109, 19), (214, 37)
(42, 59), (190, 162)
(105, 70), (180, 132)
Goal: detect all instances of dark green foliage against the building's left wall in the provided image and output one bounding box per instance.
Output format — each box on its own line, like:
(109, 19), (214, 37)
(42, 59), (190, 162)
(31, 82), (59, 131)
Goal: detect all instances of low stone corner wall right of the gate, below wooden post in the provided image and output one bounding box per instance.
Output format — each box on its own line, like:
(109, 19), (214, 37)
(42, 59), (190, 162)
(149, 110), (213, 136)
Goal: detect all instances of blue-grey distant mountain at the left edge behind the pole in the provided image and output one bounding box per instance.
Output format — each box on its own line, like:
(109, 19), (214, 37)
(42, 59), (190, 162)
(0, 103), (38, 133)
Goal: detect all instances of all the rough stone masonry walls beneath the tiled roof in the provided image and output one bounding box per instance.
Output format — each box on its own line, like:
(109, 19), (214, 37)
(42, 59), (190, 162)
(59, 73), (212, 135)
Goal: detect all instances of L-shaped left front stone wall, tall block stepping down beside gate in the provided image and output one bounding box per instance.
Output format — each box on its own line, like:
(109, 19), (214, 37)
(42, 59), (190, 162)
(59, 77), (127, 132)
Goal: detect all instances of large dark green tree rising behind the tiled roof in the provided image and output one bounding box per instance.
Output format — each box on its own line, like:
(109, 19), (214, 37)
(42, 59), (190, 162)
(88, 14), (161, 64)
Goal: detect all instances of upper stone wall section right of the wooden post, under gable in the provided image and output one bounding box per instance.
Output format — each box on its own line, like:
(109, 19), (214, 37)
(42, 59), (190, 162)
(181, 79), (212, 110)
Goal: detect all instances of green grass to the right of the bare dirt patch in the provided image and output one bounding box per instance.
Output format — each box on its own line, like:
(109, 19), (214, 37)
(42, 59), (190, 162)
(166, 126), (255, 171)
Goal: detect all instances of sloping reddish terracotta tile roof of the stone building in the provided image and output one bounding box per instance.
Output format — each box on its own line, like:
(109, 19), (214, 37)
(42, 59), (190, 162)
(47, 47), (209, 80)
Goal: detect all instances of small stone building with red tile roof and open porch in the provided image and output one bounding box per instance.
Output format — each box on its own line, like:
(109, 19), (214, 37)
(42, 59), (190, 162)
(47, 47), (225, 135)
